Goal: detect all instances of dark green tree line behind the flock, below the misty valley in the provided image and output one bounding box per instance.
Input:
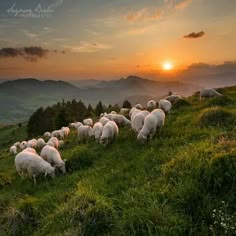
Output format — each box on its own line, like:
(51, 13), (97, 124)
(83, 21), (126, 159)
(27, 99), (131, 138)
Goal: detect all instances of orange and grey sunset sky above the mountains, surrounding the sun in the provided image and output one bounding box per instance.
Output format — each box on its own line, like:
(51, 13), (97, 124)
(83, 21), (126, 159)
(0, 0), (236, 80)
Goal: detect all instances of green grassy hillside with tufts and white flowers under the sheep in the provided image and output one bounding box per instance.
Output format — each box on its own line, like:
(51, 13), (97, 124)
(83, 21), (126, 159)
(0, 87), (236, 236)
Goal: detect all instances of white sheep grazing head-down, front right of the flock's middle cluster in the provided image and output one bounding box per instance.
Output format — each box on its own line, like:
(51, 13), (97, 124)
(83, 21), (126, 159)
(100, 121), (119, 146)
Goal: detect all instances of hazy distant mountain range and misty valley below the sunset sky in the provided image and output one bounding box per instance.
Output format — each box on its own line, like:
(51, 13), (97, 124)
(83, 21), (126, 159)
(0, 76), (236, 123)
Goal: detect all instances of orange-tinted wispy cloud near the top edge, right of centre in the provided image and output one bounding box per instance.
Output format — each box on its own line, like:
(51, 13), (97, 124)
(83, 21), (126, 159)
(125, 8), (162, 23)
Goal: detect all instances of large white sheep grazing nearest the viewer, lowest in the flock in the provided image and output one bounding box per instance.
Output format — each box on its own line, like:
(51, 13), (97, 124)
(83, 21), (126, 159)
(15, 151), (55, 184)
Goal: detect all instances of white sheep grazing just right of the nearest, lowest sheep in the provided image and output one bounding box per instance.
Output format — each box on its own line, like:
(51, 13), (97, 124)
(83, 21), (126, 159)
(40, 145), (66, 174)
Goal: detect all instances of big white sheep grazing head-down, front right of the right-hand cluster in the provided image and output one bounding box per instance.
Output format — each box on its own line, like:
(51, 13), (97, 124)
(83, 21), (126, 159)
(137, 109), (165, 143)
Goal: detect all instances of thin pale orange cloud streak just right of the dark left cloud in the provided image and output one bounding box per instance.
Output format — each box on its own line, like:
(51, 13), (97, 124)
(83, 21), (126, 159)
(66, 42), (112, 53)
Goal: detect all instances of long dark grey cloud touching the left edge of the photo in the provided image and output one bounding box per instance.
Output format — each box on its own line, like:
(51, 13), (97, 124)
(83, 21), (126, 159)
(0, 46), (64, 61)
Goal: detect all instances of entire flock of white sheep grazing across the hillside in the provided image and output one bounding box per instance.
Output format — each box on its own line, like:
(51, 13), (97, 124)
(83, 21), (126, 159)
(10, 89), (222, 183)
